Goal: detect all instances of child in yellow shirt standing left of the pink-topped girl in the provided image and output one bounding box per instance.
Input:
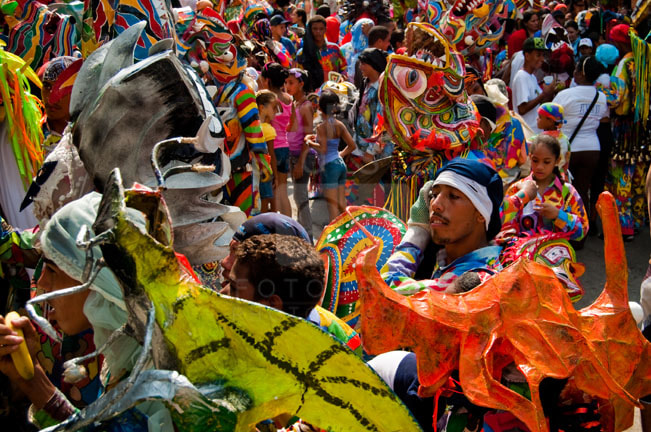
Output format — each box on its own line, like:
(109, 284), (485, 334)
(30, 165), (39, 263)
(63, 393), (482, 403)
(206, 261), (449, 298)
(255, 90), (278, 213)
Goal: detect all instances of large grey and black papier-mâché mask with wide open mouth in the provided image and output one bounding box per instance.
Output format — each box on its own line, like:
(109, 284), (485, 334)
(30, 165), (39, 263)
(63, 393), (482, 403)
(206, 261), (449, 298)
(68, 23), (238, 265)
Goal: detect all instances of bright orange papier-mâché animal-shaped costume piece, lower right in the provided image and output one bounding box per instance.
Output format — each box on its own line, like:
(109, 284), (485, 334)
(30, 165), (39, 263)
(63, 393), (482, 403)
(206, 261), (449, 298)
(356, 193), (651, 432)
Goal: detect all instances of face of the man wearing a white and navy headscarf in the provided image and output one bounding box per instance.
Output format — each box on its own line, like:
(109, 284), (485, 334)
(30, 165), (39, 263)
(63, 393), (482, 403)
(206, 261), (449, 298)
(429, 185), (483, 245)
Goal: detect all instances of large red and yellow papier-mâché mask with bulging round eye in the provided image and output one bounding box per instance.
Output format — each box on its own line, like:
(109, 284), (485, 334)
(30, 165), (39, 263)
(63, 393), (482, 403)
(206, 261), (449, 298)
(380, 23), (478, 151)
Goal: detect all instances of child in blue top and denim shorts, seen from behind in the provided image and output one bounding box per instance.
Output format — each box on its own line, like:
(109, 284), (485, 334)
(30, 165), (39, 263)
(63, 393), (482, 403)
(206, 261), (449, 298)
(308, 91), (357, 220)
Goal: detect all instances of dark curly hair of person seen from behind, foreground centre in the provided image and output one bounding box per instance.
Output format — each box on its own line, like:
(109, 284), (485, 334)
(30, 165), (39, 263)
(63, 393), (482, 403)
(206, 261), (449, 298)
(235, 234), (325, 318)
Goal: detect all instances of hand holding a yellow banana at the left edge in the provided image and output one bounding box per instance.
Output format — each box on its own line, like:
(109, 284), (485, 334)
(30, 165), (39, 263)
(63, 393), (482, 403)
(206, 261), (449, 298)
(0, 315), (40, 382)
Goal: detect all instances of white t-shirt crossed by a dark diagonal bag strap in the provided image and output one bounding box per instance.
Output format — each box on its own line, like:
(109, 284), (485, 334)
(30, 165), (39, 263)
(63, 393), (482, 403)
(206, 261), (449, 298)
(554, 85), (610, 153)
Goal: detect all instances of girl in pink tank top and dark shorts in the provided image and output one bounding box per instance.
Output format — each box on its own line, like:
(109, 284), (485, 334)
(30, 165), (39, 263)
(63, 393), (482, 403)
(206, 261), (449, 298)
(285, 68), (316, 238)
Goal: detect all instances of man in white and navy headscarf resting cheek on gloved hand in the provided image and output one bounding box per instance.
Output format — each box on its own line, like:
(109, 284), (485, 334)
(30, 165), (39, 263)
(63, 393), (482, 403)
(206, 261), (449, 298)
(382, 158), (503, 295)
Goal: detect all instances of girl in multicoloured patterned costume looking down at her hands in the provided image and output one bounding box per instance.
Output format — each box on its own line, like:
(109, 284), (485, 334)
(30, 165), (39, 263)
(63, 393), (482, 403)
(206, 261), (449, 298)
(501, 134), (588, 241)
